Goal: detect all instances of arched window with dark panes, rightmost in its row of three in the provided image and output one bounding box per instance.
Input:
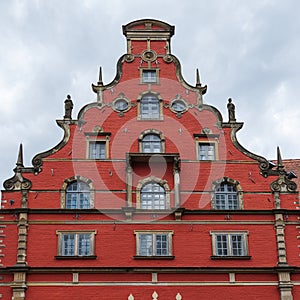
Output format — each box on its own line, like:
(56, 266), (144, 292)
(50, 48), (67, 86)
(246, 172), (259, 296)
(215, 182), (240, 209)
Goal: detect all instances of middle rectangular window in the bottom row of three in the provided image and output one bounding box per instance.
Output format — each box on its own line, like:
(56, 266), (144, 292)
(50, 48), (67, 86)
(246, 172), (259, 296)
(135, 231), (173, 257)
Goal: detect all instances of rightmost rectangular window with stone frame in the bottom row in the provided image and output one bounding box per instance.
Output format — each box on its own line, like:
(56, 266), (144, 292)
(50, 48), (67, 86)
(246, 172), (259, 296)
(211, 232), (248, 257)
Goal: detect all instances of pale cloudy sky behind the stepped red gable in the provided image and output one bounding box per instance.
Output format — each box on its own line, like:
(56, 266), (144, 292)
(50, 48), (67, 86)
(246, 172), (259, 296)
(0, 0), (300, 188)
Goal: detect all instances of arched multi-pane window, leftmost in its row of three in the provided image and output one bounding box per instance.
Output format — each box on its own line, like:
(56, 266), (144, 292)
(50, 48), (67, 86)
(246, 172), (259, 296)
(65, 181), (91, 209)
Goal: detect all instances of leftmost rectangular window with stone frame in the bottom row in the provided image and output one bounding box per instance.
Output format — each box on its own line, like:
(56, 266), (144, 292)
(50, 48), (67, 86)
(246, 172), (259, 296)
(57, 231), (95, 257)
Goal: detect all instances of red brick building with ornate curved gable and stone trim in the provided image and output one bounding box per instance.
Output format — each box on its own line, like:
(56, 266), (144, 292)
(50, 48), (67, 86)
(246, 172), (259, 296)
(0, 19), (300, 300)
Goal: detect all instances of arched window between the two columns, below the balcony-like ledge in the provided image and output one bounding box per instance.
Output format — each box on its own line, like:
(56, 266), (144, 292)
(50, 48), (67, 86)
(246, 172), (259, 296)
(141, 182), (166, 209)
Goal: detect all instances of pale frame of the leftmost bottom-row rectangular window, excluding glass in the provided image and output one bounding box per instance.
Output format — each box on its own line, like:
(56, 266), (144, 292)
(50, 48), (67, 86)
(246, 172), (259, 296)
(56, 230), (96, 257)
